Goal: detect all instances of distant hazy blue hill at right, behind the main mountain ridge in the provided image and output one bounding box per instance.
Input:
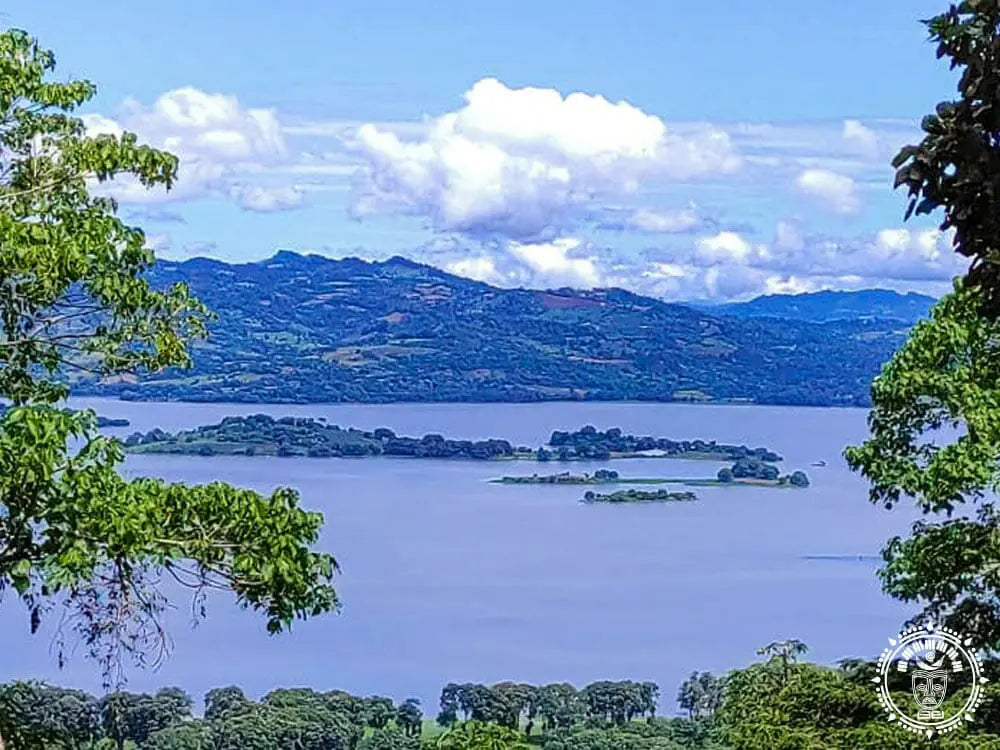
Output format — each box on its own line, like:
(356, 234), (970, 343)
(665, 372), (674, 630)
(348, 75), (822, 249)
(706, 289), (937, 324)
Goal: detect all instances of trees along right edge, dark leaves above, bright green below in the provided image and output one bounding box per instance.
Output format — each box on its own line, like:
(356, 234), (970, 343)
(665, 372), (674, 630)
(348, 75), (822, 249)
(845, 0), (1000, 651)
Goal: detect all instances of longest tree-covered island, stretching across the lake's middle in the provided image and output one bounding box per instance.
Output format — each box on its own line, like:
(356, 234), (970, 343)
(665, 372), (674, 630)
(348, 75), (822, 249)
(125, 414), (781, 462)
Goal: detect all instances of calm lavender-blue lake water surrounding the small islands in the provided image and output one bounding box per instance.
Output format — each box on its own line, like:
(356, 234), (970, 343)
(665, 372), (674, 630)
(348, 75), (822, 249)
(0, 399), (911, 715)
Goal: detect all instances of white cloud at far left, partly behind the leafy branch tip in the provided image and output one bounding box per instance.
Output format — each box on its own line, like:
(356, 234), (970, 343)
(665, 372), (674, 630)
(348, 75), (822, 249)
(83, 87), (287, 210)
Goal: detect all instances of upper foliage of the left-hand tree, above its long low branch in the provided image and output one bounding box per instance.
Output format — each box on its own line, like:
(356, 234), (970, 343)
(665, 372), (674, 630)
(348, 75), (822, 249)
(0, 30), (205, 403)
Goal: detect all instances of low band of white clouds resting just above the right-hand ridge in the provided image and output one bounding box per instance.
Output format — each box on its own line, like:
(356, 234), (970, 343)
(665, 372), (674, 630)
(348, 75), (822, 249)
(418, 220), (966, 301)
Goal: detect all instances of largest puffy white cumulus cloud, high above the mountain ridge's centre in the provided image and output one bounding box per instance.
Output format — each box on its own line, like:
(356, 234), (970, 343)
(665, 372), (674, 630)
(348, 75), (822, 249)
(352, 78), (740, 240)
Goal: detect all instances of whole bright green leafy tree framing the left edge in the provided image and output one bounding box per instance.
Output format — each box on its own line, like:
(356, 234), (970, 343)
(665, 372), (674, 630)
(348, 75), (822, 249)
(0, 31), (337, 676)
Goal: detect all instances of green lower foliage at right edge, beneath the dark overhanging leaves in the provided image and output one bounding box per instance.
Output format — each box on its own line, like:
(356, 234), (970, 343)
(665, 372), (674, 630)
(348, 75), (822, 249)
(845, 289), (1000, 649)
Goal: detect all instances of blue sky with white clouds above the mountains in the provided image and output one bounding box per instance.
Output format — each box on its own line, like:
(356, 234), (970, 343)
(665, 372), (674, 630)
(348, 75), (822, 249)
(0, 0), (962, 299)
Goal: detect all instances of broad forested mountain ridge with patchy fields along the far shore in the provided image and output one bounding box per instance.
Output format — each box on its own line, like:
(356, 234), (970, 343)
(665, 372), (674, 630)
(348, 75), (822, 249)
(74, 252), (906, 405)
